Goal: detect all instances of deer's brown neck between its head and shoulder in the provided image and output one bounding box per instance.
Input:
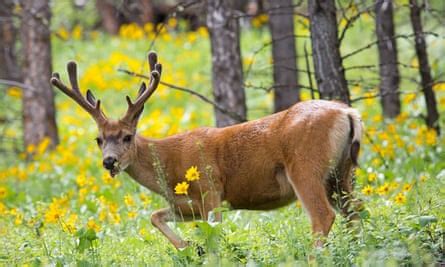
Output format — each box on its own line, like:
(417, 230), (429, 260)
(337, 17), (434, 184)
(125, 135), (165, 195)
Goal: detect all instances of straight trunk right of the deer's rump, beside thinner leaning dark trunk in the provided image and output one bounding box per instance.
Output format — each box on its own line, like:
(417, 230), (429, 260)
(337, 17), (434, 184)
(375, 0), (400, 118)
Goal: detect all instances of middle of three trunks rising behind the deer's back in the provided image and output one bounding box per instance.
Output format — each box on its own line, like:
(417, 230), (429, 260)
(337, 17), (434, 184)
(267, 0), (300, 112)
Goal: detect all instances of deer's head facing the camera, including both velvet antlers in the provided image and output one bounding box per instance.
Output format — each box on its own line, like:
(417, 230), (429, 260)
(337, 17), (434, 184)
(51, 52), (162, 176)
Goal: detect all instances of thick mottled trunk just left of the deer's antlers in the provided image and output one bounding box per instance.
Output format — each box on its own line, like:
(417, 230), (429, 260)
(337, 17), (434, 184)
(21, 0), (59, 153)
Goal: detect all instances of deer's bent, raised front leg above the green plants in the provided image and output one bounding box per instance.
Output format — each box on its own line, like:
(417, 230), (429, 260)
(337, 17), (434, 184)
(151, 208), (188, 249)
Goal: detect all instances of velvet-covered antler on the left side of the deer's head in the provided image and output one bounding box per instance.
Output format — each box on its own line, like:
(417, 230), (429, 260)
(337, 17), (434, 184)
(51, 61), (106, 123)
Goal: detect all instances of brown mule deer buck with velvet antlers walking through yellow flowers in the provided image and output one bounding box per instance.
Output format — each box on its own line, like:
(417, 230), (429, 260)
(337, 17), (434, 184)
(51, 52), (362, 251)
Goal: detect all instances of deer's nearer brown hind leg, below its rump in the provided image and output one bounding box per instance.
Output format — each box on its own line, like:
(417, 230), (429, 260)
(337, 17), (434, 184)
(287, 162), (335, 247)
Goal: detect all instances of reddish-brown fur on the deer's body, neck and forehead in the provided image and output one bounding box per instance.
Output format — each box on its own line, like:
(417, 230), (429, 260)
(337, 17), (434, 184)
(109, 100), (357, 247)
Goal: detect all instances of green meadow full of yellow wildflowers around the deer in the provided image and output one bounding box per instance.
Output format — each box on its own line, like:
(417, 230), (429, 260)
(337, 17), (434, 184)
(0, 17), (445, 266)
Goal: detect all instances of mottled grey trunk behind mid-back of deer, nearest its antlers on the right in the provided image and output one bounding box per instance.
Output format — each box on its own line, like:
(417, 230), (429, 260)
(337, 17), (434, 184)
(207, 0), (246, 127)
